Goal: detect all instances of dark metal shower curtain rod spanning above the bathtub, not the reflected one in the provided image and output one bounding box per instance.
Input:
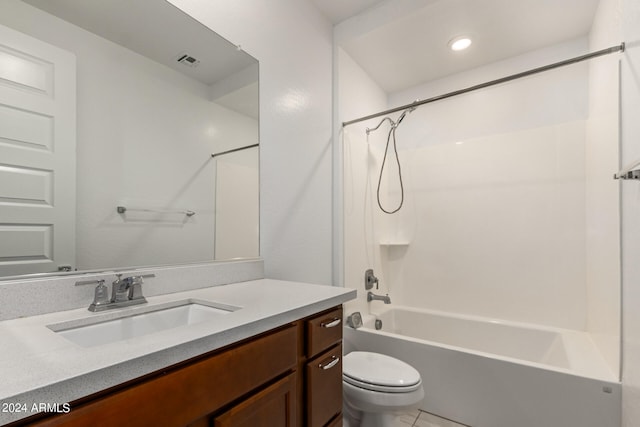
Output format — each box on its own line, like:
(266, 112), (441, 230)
(342, 43), (624, 127)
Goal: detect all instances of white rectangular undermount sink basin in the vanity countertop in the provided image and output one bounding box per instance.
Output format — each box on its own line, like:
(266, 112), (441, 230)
(47, 301), (239, 347)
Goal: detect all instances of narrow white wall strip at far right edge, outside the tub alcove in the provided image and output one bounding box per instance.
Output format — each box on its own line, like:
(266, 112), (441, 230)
(620, 0), (640, 427)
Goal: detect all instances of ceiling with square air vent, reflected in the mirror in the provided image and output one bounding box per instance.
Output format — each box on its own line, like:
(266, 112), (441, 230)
(24, 0), (259, 119)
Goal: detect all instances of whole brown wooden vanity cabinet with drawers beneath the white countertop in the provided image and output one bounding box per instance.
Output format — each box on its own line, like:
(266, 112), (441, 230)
(14, 307), (342, 427)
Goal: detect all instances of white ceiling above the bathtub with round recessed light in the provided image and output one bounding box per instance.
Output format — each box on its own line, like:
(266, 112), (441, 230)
(311, 0), (598, 93)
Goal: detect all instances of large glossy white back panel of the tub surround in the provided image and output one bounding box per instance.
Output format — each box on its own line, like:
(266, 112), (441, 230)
(388, 122), (587, 330)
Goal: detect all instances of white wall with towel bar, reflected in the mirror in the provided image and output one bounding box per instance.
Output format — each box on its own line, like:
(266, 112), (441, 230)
(2, 1), (258, 270)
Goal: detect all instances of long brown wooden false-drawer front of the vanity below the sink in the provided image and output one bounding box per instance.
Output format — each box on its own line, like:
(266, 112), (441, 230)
(28, 324), (297, 427)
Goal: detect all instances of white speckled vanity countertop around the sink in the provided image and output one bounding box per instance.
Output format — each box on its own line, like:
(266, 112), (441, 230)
(0, 279), (356, 425)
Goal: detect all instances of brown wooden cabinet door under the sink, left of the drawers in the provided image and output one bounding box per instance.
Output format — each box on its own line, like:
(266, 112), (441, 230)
(214, 372), (296, 427)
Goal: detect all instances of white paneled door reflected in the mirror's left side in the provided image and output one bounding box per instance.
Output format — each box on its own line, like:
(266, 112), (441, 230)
(0, 25), (76, 276)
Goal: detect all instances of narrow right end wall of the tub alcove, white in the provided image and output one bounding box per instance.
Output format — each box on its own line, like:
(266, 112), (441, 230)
(585, 0), (622, 382)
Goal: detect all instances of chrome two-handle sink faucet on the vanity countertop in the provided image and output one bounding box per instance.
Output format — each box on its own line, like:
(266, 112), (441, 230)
(76, 274), (156, 311)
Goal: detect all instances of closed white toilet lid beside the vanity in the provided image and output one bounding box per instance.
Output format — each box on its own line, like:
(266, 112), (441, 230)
(342, 351), (422, 393)
